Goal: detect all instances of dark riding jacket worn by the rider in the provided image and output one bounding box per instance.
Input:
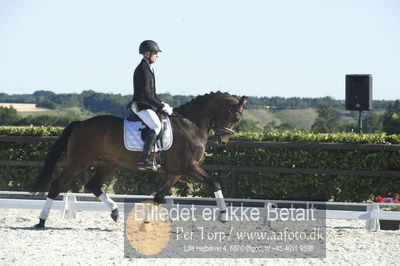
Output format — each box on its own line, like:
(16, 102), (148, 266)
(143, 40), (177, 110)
(132, 59), (164, 111)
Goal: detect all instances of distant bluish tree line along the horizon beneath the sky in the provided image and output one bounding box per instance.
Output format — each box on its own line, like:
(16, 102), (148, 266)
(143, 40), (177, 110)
(0, 90), (393, 111)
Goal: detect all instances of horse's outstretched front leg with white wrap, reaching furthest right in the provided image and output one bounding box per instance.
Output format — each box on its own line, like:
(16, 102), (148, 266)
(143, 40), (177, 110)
(186, 165), (228, 222)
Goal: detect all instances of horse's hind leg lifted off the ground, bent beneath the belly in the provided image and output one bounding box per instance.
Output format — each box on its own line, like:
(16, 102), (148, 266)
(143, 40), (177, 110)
(85, 163), (119, 222)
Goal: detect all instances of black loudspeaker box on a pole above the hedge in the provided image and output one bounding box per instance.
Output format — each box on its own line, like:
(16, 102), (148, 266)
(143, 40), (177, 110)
(346, 74), (372, 111)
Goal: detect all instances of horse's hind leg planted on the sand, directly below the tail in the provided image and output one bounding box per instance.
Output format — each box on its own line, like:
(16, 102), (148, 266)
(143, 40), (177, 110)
(35, 163), (89, 228)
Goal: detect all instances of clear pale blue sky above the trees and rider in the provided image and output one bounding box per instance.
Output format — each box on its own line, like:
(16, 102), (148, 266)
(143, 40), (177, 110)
(0, 0), (400, 99)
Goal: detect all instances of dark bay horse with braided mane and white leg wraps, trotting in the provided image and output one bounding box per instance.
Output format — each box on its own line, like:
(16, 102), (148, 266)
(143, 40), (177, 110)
(32, 92), (247, 228)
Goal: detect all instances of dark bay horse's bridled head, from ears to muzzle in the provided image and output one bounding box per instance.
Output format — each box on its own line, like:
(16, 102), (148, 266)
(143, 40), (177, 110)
(212, 96), (247, 146)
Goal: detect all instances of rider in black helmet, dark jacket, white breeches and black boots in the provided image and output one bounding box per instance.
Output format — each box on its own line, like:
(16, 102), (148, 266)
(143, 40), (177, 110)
(131, 40), (173, 170)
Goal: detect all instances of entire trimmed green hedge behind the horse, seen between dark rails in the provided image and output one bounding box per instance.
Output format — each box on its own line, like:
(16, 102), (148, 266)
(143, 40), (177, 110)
(0, 127), (400, 201)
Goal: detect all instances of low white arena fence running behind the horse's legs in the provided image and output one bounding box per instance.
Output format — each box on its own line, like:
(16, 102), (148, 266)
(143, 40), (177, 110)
(0, 191), (400, 231)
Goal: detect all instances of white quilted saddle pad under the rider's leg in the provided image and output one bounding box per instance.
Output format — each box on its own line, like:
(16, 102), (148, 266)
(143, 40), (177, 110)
(124, 116), (173, 152)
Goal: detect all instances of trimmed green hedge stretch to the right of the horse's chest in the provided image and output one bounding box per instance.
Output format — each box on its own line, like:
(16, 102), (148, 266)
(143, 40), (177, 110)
(203, 131), (400, 201)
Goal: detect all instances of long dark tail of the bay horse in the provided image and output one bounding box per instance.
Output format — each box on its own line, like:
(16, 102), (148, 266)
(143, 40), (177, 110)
(31, 121), (81, 192)
